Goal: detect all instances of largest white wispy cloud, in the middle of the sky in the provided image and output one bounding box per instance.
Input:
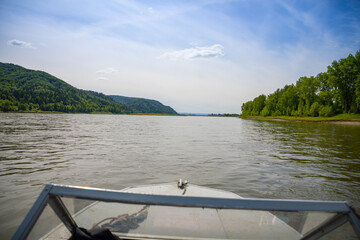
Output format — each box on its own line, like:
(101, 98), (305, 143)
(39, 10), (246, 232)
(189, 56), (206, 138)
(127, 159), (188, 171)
(160, 44), (224, 60)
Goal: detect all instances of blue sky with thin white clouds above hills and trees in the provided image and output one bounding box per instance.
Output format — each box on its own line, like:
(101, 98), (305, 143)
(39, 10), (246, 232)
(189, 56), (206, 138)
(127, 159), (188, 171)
(0, 0), (360, 113)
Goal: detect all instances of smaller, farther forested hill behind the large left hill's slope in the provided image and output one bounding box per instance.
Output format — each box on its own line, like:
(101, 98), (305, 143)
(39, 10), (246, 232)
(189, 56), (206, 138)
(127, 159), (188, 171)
(109, 95), (177, 115)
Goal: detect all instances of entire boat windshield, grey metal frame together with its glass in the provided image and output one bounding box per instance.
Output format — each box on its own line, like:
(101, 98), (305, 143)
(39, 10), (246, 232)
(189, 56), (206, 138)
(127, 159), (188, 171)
(13, 185), (360, 239)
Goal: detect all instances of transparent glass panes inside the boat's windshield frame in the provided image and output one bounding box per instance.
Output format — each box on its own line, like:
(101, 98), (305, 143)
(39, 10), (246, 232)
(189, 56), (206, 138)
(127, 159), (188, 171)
(28, 197), (357, 239)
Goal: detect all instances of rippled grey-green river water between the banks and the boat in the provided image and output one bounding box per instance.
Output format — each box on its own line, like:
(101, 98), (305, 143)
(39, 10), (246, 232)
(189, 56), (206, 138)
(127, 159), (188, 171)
(0, 113), (360, 239)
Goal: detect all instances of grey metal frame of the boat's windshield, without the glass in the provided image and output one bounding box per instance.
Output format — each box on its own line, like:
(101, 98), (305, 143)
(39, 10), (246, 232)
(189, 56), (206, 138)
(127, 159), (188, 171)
(12, 184), (360, 240)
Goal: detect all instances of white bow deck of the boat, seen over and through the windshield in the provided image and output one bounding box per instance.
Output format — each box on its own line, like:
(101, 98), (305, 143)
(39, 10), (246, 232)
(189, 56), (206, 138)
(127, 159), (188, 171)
(38, 183), (301, 239)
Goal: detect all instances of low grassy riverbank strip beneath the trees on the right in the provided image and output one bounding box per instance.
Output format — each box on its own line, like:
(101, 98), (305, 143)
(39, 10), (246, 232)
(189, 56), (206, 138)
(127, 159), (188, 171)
(240, 114), (360, 126)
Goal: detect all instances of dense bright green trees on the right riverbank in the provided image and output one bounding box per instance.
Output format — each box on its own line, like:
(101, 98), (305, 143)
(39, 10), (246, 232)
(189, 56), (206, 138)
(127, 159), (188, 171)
(241, 50), (360, 117)
